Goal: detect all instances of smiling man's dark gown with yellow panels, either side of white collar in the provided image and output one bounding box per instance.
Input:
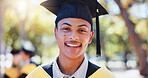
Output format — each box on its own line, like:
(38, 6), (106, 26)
(26, 61), (115, 78)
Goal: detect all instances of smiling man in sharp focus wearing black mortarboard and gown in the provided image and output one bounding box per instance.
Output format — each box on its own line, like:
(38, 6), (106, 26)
(27, 0), (114, 78)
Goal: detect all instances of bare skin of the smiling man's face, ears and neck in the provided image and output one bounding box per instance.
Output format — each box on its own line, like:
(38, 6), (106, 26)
(54, 18), (94, 75)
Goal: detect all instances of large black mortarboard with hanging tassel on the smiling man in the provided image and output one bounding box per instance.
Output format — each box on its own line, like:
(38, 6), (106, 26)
(41, 0), (108, 56)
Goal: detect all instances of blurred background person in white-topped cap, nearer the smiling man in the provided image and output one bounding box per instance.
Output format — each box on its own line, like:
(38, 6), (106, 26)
(19, 41), (38, 78)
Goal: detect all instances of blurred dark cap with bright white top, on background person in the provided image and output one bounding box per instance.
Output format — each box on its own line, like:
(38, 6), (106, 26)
(21, 41), (36, 57)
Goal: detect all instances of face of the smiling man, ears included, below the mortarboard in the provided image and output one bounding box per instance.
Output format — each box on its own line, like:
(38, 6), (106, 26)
(54, 18), (94, 58)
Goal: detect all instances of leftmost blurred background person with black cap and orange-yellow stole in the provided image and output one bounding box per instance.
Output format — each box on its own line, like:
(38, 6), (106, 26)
(4, 50), (21, 78)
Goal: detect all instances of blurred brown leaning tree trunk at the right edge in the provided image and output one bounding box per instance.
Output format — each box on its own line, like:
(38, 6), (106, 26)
(115, 0), (148, 77)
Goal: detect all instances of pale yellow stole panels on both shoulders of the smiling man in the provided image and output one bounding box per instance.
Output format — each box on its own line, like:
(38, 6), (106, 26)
(26, 66), (115, 78)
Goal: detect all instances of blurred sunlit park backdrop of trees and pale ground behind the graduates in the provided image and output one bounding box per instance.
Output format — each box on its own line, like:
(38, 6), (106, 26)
(0, 0), (148, 78)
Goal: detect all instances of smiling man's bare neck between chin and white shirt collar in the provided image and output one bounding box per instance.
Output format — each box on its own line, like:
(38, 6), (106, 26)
(57, 55), (84, 76)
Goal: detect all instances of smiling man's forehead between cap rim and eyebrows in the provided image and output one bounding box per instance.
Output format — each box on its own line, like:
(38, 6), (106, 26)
(58, 18), (91, 28)
